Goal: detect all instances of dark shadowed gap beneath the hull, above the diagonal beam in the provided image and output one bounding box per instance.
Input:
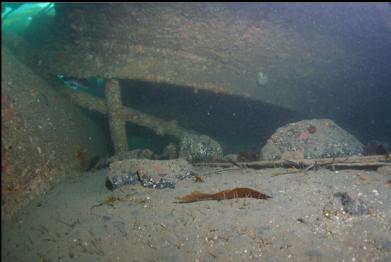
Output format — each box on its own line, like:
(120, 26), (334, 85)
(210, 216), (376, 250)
(120, 80), (305, 153)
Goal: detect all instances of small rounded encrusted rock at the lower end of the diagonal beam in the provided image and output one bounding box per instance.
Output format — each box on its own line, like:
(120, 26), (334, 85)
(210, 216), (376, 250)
(179, 134), (223, 162)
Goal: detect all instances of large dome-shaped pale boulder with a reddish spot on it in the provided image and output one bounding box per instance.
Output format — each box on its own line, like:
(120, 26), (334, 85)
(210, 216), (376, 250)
(260, 119), (364, 160)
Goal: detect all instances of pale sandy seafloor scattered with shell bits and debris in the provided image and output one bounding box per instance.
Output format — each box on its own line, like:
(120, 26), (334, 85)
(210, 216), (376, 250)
(1, 167), (391, 261)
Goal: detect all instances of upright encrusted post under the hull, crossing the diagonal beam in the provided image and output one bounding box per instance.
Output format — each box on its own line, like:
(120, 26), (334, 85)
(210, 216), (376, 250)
(105, 79), (128, 154)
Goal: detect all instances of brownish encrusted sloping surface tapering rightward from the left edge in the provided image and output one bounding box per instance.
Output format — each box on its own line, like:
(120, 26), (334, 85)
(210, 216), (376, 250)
(1, 48), (107, 219)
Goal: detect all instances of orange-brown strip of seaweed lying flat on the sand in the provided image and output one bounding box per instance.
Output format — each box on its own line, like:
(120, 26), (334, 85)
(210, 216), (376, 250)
(176, 187), (271, 203)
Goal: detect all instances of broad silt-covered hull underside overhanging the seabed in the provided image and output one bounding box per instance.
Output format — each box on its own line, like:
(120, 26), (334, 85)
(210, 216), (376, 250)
(22, 3), (370, 112)
